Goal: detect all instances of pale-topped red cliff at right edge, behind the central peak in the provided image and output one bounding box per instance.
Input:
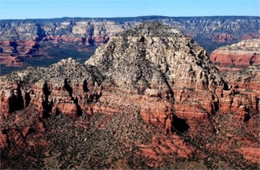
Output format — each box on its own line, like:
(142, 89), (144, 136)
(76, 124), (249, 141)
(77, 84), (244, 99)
(210, 39), (260, 71)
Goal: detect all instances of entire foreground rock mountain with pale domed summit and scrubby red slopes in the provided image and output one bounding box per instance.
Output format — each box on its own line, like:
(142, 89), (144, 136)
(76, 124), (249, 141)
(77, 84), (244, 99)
(0, 22), (260, 169)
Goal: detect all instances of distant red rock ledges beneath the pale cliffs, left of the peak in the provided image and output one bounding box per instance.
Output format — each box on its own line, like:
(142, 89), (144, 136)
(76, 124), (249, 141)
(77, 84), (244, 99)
(0, 35), (109, 67)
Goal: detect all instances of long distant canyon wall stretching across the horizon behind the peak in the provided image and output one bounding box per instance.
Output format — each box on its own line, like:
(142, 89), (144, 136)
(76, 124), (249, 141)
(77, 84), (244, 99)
(0, 17), (259, 42)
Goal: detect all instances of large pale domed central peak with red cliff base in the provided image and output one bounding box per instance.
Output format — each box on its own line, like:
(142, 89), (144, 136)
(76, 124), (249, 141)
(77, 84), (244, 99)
(86, 23), (228, 131)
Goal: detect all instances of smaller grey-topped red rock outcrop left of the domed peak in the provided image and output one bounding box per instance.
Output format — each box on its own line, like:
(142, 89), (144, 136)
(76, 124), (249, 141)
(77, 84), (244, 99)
(1, 58), (102, 118)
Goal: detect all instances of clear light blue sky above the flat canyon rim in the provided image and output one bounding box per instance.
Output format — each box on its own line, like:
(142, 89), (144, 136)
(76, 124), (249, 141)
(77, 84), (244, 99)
(0, 0), (260, 19)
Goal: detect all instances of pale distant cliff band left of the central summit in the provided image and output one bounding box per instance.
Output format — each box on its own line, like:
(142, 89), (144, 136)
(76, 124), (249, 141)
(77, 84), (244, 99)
(0, 19), (138, 42)
